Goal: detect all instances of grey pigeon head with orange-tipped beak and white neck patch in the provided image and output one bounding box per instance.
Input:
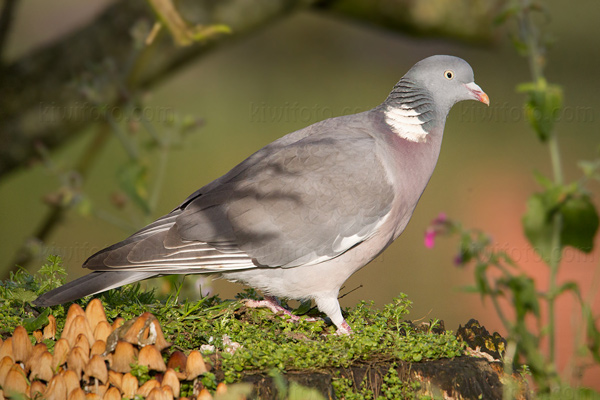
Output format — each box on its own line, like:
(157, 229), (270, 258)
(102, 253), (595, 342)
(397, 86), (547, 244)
(382, 56), (490, 142)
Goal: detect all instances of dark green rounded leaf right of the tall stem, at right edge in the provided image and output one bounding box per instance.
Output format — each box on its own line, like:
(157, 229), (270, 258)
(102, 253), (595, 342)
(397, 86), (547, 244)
(560, 194), (598, 253)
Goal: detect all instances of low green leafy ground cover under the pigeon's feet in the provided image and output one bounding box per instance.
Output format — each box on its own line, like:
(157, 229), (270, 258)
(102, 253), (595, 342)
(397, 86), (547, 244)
(5, 257), (464, 398)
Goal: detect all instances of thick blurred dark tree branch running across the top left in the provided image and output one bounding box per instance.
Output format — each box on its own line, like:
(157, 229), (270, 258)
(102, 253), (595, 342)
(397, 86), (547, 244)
(0, 0), (505, 178)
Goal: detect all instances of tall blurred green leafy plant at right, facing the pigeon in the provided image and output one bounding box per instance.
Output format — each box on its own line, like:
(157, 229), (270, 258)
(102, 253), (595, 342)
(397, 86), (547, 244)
(426, 0), (600, 398)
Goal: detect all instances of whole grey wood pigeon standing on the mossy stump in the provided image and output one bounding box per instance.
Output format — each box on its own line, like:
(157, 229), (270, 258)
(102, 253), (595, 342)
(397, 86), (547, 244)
(34, 56), (489, 333)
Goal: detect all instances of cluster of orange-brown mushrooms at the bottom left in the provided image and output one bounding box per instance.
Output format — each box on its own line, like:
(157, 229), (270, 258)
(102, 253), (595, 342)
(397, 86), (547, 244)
(0, 299), (232, 400)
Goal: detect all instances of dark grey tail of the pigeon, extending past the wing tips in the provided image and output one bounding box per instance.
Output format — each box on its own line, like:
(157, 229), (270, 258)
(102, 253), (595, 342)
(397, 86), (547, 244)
(32, 271), (156, 307)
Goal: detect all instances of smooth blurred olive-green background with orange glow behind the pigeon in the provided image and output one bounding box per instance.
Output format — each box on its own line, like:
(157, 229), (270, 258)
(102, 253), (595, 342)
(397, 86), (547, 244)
(0, 0), (600, 387)
